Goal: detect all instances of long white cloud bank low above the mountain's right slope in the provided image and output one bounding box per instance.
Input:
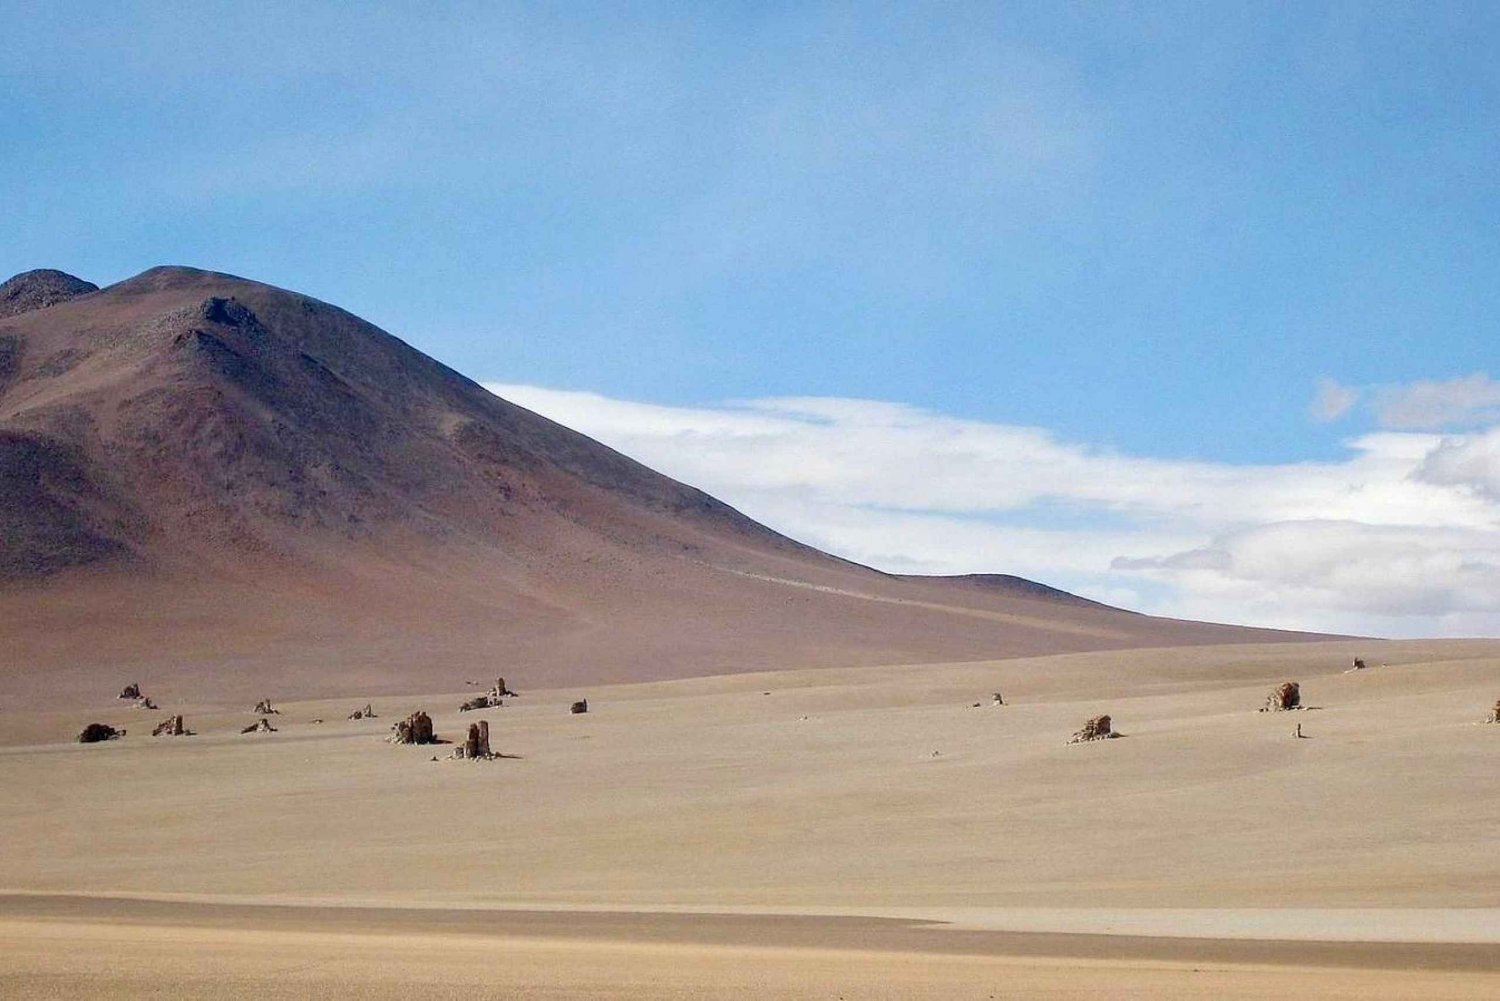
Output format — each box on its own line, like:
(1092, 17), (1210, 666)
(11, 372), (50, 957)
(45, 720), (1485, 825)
(488, 384), (1500, 636)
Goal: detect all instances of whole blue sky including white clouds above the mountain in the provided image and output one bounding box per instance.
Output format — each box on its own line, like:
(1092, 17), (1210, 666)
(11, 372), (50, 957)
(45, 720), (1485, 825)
(0, 0), (1500, 636)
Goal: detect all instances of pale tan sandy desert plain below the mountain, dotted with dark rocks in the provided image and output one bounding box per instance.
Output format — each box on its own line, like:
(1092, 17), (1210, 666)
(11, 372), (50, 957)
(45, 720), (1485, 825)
(0, 641), (1500, 999)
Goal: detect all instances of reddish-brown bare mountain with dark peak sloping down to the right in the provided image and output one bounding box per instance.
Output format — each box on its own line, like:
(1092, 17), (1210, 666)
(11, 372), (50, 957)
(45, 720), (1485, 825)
(0, 267), (1332, 702)
